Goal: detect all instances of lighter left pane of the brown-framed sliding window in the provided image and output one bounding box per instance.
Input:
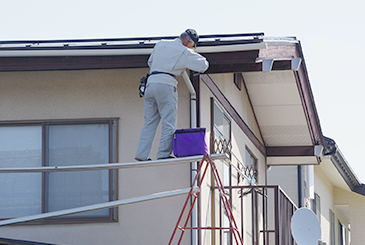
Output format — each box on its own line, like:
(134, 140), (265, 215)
(0, 126), (42, 219)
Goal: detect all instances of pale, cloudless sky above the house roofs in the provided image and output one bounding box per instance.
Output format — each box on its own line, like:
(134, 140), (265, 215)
(0, 0), (365, 182)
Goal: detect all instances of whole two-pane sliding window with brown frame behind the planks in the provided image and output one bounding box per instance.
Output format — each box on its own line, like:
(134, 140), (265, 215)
(0, 119), (117, 220)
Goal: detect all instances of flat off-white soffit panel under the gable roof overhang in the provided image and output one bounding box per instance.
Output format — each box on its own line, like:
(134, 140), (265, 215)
(243, 70), (312, 146)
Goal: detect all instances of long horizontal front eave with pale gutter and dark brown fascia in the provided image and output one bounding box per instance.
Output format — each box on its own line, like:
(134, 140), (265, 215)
(0, 33), (266, 71)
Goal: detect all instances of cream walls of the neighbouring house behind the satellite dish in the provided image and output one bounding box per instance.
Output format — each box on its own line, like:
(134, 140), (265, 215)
(268, 162), (365, 245)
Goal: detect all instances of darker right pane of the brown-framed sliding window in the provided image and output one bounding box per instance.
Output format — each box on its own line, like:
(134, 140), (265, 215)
(46, 124), (109, 216)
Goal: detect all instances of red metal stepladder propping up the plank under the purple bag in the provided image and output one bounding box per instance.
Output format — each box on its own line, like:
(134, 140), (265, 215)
(169, 155), (243, 245)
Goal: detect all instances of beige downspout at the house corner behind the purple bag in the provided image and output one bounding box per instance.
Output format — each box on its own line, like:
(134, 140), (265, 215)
(182, 70), (198, 245)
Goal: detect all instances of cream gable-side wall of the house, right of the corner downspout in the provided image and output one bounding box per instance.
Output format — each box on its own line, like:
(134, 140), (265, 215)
(200, 74), (266, 244)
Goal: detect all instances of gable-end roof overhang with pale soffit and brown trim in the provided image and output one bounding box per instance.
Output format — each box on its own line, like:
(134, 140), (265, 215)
(242, 39), (323, 165)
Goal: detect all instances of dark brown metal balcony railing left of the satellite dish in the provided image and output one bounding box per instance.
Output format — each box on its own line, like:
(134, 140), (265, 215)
(216, 186), (297, 245)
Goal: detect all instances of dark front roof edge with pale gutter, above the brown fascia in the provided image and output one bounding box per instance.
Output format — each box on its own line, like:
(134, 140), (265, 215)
(0, 33), (264, 57)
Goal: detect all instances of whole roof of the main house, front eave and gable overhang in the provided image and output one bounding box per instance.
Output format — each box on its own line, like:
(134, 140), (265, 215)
(0, 33), (361, 193)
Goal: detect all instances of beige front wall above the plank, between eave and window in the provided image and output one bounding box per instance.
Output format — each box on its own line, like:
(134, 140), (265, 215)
(0, 69), (190, 160)
